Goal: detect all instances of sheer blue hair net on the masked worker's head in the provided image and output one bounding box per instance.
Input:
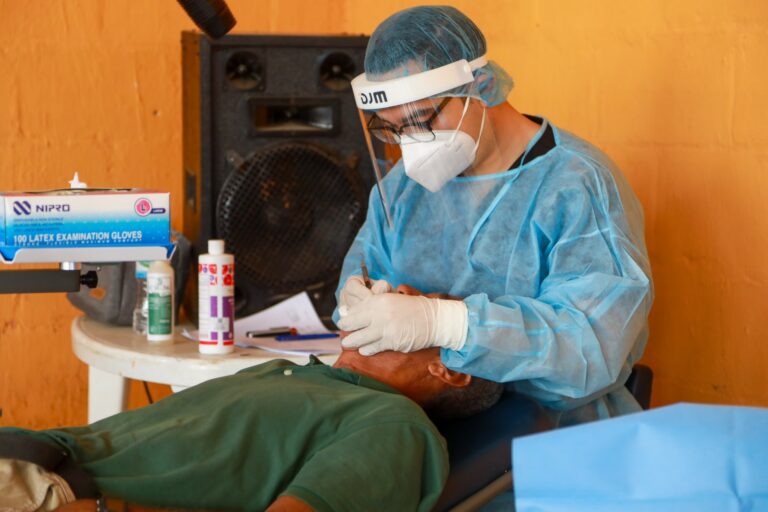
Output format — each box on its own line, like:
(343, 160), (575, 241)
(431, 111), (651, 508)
(365, 6), (514, 107)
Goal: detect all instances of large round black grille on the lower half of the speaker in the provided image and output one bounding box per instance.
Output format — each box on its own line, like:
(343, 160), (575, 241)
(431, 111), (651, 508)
(216, 142), (366, 292)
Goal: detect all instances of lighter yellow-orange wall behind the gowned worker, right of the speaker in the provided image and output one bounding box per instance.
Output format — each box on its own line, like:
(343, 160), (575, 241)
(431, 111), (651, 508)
(390, 0), (768, 406)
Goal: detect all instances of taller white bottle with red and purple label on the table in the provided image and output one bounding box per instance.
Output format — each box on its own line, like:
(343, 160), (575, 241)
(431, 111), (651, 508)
(197, 240), (235, 354)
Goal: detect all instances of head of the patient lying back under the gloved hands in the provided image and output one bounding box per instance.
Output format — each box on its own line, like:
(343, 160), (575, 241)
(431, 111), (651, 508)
(334, 286), (503, 418)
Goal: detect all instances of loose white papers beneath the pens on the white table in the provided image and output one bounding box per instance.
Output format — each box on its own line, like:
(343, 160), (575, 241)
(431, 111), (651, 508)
(182, 292), (341, 355)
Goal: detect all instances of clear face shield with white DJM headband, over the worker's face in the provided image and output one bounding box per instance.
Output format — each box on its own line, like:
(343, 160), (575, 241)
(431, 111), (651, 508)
(352, 57), (496, 226)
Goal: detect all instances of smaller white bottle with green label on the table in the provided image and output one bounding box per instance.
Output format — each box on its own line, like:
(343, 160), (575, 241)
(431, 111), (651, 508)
(147, 261), (174, 344)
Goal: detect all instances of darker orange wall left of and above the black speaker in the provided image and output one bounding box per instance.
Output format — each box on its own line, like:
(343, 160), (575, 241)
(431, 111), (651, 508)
(0, 0), (342, 428)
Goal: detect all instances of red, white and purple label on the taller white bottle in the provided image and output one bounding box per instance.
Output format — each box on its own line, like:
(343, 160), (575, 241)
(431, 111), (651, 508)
(197, 260), (235, 346)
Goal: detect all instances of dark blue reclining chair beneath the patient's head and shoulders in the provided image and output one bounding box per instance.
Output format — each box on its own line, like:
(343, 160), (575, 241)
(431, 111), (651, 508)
(434, 365), (653, 512)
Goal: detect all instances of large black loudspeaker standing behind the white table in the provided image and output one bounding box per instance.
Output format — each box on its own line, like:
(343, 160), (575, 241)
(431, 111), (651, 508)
(182, 32), (375, 323)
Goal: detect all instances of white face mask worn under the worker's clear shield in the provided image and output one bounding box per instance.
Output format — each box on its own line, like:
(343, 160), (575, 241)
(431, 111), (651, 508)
(400, 98), (485, 192)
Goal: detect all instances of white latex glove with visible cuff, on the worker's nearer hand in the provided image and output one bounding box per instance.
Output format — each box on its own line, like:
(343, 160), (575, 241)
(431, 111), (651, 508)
(339, 293), (468, 356)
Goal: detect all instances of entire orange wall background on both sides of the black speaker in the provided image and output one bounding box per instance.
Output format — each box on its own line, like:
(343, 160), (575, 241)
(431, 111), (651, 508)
(0, 0), (768, 427)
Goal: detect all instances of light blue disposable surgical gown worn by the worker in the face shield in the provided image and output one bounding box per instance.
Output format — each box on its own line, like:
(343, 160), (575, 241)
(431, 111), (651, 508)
(334, 119), (653, 425)
